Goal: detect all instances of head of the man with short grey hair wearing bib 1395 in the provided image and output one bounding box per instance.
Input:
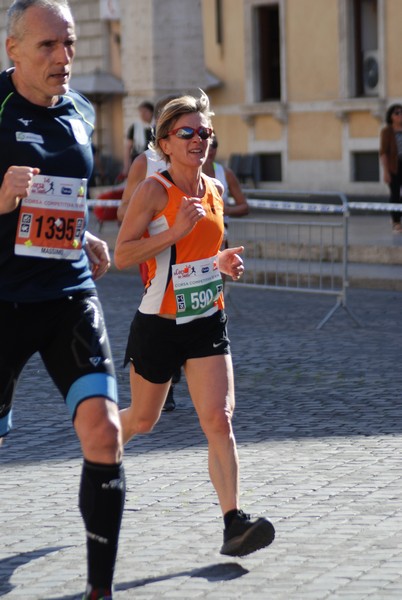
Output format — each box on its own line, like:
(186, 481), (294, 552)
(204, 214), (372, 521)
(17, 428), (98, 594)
(7, 6), (76, 106)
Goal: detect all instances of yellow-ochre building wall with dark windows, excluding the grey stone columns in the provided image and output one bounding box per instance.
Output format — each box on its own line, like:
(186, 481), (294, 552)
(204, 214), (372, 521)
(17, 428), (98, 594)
(203, 0), (402, 195)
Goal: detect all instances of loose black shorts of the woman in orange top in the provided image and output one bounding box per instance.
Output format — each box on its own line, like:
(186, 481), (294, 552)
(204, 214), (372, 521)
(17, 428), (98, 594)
(124, 310), (230, 383)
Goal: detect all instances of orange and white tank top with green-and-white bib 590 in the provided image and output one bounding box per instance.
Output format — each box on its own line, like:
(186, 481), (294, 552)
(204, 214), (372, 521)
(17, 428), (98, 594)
(139, 173), (224, 323)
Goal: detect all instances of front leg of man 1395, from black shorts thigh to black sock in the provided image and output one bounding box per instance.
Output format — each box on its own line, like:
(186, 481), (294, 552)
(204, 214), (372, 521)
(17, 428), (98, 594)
(41, 294), (125, 600)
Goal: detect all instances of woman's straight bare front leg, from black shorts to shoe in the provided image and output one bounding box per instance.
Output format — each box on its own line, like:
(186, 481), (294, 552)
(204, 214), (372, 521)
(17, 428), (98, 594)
(185, 354), (239, 514)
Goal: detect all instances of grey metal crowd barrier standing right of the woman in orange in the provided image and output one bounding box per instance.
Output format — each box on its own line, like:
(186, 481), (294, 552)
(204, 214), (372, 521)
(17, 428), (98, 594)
(225, 189), (360, 329)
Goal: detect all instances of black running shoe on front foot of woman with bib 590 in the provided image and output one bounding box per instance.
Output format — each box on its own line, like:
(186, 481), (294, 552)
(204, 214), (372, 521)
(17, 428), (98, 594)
(221, 510), (275, 556)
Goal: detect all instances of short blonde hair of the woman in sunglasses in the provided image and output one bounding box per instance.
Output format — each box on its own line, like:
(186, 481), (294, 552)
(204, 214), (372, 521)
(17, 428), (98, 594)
(150, 90), (214, 162)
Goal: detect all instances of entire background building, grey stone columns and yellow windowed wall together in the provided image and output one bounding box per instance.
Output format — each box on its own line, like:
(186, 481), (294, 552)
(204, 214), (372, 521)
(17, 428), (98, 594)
(0, 0), (402, 195)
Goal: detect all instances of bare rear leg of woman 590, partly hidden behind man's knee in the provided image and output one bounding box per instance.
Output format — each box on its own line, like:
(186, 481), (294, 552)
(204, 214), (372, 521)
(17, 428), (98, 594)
(120, 365), (171, 444)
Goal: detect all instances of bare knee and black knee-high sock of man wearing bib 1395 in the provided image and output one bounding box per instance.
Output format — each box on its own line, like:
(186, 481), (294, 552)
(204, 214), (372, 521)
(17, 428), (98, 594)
(74, 398), (125, 600)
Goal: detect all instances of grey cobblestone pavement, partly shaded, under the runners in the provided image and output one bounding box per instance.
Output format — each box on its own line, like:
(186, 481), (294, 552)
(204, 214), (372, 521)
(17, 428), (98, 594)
(0, 273), (402, 600)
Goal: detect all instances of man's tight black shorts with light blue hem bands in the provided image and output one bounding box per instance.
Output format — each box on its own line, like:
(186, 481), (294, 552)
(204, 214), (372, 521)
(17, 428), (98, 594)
(0, 290), (117, 436)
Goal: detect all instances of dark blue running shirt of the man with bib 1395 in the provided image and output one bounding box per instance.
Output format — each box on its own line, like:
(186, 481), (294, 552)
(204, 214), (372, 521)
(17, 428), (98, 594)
(0, 69), (95, 302)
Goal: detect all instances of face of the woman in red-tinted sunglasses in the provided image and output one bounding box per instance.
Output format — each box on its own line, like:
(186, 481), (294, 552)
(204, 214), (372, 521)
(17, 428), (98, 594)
(160, 113), (211, 169)
